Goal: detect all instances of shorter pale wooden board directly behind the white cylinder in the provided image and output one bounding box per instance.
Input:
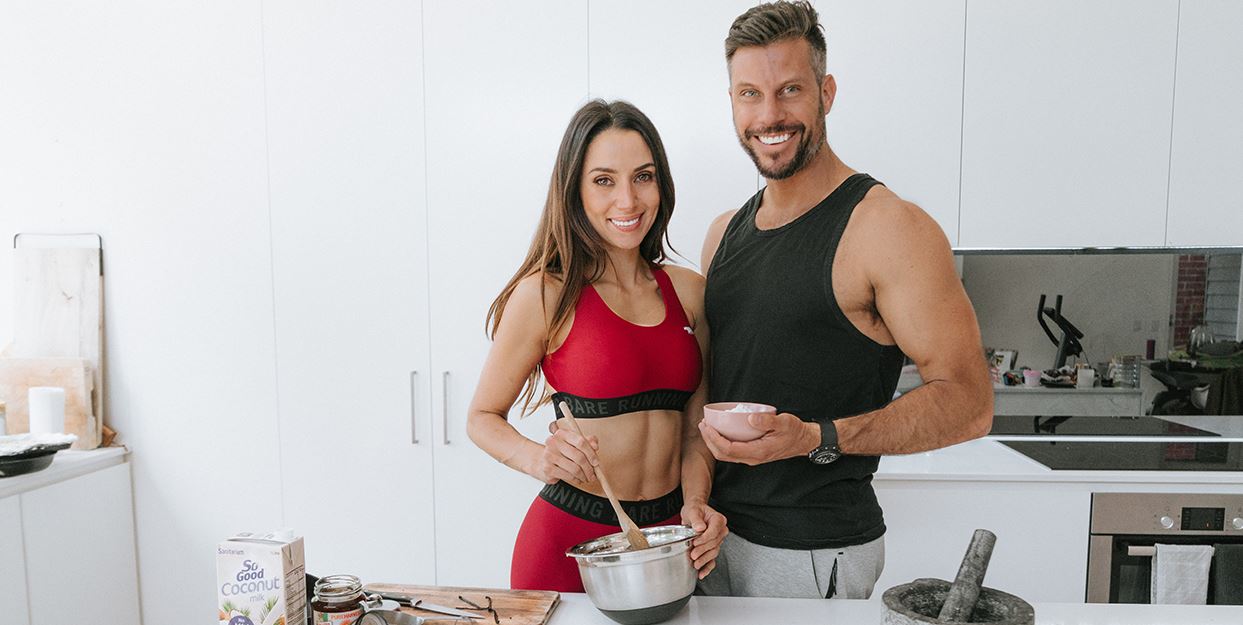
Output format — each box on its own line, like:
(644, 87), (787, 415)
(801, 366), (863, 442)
(0, 358), (99, 450)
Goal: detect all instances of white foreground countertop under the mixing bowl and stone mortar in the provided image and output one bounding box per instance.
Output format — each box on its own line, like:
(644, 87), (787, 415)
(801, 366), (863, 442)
(548, 591), (1243, 625)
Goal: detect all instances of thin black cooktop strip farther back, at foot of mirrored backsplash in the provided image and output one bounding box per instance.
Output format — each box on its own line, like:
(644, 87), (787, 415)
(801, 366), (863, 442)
(988, 415), (1217, 437)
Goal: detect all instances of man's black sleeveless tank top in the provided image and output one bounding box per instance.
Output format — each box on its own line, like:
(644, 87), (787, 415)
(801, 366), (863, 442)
(705, 174), (902, 549)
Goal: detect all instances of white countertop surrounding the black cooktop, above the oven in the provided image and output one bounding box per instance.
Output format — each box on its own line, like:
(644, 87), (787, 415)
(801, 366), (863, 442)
(874, 437), (1243, 485)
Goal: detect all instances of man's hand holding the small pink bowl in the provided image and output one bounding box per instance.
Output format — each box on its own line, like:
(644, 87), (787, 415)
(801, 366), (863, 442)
(700, 413), (820, 466)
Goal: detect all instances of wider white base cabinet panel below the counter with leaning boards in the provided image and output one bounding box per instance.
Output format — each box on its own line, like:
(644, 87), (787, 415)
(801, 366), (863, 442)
(22, 463), (139, 625)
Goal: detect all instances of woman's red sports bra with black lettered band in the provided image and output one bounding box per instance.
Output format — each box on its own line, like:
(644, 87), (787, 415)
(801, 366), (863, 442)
(541, 268), (704, 419)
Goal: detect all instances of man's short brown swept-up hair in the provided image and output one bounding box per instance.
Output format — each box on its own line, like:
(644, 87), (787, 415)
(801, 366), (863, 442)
(725, 0), (825, 77)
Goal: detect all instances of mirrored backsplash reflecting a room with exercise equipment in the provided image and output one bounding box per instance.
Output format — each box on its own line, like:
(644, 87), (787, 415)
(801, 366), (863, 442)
(957, 249), (1243, 415)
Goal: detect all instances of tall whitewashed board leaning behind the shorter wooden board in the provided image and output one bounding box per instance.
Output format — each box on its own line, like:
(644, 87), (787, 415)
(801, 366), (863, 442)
(7, 234), (104, 449)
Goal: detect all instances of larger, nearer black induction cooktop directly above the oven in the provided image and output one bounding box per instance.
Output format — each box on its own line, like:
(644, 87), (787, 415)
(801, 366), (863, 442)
(998, 439), (1243, 471)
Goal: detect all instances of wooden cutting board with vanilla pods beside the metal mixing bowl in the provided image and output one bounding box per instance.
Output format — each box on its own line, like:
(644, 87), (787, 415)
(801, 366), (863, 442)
(367, 584), (561, 625)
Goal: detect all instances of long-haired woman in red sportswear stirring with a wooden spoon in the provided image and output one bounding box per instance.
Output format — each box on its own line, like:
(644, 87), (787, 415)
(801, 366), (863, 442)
(467, 101), (725, 593)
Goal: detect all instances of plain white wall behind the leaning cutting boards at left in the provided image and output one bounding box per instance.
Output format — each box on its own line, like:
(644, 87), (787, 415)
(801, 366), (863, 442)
(0, 0), (282, 624)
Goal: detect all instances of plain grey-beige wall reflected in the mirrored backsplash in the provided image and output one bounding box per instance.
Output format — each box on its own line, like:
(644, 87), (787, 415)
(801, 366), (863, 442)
(962, 253), (1178, 369)
